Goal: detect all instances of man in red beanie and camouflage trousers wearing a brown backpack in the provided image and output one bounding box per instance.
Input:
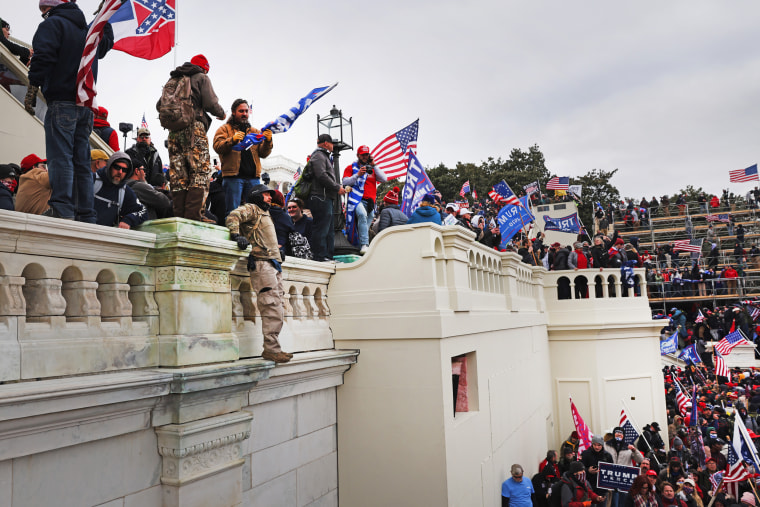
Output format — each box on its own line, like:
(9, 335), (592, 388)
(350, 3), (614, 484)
(156, 55), (226, 220)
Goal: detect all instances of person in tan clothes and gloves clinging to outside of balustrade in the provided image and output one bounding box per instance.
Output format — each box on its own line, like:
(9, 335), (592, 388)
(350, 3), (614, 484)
(225, 185), (293, 363)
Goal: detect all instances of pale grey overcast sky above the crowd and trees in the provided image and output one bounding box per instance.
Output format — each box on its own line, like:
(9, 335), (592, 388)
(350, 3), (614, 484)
(5, 0), (760, 198)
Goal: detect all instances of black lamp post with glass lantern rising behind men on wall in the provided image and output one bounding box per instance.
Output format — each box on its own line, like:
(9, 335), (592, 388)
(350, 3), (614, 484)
(317, 105), (359, 255)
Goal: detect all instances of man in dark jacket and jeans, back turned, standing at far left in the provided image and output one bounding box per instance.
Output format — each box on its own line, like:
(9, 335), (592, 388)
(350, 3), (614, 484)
(24, 0), (113, 223)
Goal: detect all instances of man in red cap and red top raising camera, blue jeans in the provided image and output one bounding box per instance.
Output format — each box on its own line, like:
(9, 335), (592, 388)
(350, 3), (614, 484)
(343, 146), (388, 253)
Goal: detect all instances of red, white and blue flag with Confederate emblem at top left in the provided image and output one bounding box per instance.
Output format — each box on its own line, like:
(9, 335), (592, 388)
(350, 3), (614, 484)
(111, 0), (177, 60)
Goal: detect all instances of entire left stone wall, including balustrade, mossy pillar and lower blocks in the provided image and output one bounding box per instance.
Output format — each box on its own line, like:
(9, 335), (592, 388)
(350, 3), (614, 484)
(0, 211), (358, 507)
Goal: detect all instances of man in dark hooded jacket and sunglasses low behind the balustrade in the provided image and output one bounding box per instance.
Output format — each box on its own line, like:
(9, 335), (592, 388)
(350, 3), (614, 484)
(91, 151), (148, 229)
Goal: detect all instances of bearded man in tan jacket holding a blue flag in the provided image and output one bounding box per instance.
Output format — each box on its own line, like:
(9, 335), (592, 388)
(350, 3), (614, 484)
(214, 99), (272, 219)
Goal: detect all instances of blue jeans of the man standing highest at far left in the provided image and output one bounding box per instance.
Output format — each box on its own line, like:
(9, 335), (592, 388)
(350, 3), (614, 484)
(45, 101), (97, 224)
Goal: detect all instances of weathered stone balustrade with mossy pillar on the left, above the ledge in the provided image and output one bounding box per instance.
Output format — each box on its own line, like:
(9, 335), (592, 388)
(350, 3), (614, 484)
(0, 210), (334, 381)
